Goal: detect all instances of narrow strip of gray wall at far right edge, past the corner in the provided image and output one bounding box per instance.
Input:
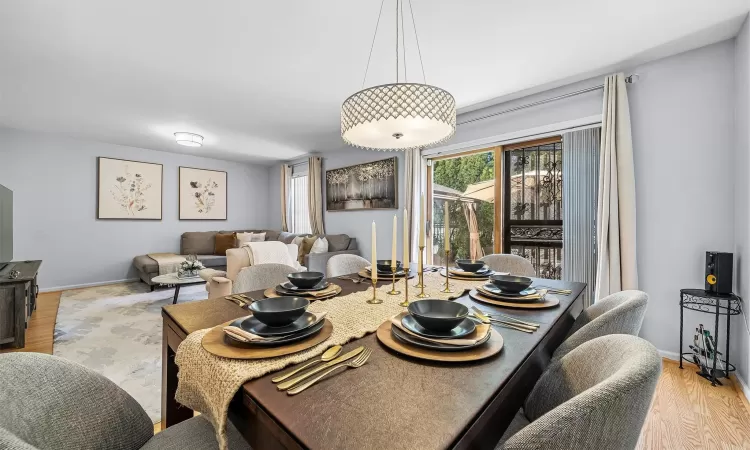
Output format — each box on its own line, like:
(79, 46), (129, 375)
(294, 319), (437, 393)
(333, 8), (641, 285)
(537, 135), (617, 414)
(731, 16), (750, 390)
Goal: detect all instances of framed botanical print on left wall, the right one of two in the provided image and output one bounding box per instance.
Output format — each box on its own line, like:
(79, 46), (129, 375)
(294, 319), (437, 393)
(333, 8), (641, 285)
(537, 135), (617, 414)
(179, 167), (227, 220)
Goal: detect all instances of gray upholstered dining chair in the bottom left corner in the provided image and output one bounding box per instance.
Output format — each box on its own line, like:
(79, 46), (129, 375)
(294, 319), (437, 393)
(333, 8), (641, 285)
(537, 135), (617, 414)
(0, 353), (250, 450)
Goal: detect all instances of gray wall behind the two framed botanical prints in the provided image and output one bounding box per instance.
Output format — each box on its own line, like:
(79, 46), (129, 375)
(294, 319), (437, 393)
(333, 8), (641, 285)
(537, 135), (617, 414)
(0, 129), (269, 289)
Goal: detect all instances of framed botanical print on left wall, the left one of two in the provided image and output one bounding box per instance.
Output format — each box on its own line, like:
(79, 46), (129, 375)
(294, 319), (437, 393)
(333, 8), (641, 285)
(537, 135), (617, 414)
(96, 156), (163, 220)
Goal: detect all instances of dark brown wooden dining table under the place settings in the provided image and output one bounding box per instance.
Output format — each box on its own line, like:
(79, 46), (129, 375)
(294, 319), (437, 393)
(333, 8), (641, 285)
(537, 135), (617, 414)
(161, 279), (585, 450)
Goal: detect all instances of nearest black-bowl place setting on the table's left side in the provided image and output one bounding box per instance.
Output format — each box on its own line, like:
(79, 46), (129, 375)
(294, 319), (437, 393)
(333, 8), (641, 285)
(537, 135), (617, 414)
(201, 297), (333, 359)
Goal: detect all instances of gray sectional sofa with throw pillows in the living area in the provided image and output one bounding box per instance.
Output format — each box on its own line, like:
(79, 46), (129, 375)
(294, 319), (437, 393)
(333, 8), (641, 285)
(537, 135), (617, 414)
(133, 230), (359, 290)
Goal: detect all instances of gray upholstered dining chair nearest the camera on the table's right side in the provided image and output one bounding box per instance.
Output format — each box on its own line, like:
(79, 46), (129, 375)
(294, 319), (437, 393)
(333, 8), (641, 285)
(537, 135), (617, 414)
(498, 334), (661, 450)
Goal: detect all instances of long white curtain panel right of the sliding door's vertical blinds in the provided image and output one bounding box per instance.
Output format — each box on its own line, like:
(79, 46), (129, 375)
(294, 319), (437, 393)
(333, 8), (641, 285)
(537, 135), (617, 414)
(594, 73), (638, 299)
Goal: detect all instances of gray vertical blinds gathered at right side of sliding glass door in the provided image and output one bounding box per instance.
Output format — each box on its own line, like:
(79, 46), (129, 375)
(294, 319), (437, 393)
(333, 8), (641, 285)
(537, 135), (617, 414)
(562, 128), (601, 307)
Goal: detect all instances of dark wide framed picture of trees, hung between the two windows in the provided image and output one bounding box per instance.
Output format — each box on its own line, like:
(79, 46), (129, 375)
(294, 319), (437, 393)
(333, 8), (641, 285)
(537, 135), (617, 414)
(325, 157), (398, 212)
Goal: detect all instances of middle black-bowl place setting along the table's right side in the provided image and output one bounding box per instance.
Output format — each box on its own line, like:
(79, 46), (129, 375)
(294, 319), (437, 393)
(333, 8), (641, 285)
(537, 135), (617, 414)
(469, 274), (560, 309)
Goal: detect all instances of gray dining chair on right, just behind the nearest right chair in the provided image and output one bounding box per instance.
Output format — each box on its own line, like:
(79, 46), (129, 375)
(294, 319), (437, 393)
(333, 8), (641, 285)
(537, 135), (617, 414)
(552, 290), (648, 359)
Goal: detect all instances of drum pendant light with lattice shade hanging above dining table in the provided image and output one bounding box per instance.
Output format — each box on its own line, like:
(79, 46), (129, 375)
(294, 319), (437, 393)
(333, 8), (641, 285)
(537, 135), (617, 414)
(341, 0), (456, 151)
